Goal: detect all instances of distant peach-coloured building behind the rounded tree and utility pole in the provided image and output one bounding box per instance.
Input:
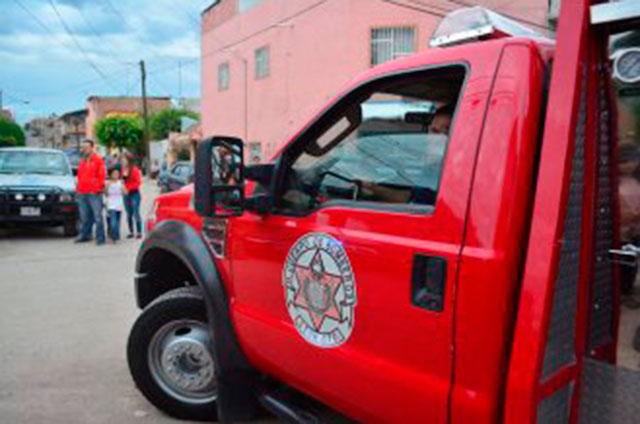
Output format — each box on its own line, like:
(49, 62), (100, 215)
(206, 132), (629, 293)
(86, 96), (171, 139)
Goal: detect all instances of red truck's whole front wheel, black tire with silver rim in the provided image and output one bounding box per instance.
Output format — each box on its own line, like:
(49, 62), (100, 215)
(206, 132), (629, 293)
(127, 287), (218, 421)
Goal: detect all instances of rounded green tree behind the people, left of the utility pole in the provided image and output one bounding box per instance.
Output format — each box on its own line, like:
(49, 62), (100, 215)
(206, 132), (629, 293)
(94, 116), (142, 152)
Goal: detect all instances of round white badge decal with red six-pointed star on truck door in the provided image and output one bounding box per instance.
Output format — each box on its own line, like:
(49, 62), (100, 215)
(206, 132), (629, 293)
(282, 233), (356, 348)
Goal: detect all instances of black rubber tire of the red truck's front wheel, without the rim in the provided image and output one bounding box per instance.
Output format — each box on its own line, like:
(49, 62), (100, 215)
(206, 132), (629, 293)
(127, 287), (217, 421)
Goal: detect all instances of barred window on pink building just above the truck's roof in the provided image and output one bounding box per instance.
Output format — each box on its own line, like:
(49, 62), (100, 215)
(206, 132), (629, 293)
(371, 27), (416, 66)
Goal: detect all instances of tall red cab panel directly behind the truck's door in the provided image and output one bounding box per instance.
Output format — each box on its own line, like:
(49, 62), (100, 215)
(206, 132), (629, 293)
(451, 41), (547, 422)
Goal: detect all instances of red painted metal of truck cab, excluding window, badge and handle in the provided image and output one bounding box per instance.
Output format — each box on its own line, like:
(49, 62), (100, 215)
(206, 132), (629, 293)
(149, 39), (552, 422)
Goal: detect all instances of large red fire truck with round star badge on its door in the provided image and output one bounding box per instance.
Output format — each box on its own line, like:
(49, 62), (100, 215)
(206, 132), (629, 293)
(128, 0), (640, 424)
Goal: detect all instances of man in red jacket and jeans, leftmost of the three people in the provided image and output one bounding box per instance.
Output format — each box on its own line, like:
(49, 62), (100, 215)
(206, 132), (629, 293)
(76, 139), (105, 245)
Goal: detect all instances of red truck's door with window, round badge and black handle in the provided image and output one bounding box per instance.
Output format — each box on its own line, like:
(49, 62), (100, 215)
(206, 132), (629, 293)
(227, 59), (498, 422)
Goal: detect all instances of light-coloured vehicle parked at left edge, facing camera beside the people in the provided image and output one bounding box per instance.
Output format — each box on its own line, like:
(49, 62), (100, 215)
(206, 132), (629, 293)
(0, 147), (78, 237)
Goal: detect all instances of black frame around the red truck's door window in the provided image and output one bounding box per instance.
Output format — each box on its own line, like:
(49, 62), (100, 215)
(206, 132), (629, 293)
(270, 60), (471, 216)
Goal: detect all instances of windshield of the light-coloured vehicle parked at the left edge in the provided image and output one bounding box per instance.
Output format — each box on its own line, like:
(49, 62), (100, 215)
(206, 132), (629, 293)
(0, 151), (71, 175)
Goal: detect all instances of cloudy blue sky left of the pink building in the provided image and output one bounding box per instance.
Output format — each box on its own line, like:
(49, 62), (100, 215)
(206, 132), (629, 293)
(0, 0), (212, 122)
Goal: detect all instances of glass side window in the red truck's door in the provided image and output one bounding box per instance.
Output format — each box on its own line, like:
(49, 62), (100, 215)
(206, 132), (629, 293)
(280, 66), (465, 213)
